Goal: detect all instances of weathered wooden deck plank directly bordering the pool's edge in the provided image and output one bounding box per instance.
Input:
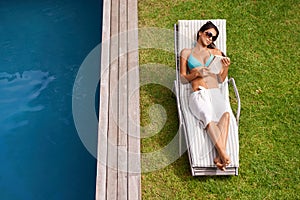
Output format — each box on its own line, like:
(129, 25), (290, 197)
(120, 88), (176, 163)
(95, 0), (111, 200)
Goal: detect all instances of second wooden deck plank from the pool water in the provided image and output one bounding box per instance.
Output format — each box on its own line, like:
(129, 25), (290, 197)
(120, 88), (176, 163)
(106, 0), (119, 199)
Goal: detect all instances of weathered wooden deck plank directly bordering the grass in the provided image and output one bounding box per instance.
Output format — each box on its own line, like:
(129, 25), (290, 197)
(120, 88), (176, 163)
(128, 0), (141, 200)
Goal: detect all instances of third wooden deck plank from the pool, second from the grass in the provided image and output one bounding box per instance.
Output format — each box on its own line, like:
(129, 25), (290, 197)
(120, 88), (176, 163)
(117, 0), (128, 200)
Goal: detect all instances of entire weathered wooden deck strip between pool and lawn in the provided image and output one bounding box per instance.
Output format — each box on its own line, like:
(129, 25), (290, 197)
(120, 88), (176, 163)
(96, 0), (141, 200)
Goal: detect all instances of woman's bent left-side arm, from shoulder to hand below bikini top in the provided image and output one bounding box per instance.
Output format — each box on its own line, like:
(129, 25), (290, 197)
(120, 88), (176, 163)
(180, 49), (202, 83)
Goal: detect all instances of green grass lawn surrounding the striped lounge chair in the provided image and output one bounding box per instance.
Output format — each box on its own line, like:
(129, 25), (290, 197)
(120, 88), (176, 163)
(138, 0), (300, 199)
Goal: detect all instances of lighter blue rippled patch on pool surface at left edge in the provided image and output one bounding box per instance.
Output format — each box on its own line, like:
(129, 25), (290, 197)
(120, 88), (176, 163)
(0, 71), (55, 130)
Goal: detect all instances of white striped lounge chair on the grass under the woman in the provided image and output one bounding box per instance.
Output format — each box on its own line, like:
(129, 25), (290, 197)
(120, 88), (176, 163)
(174, 19), (241, 176)
